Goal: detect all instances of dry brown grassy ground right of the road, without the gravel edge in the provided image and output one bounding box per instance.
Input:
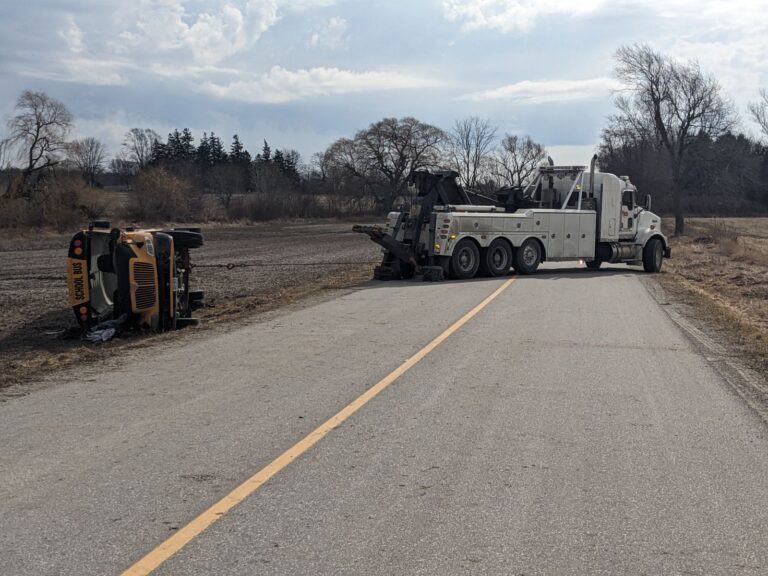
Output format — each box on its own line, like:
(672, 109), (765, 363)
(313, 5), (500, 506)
(660, 218), (768, 369)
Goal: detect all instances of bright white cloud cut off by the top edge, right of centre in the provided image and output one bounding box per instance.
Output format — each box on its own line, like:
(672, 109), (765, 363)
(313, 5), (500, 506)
(443, 0), (608, 32)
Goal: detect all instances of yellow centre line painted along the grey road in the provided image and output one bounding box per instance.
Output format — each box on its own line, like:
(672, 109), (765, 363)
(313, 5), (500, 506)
(122, 278), (515, 576)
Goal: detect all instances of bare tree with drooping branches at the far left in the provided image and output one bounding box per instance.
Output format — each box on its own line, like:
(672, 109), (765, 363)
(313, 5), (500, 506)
(8, 90), (72, 194)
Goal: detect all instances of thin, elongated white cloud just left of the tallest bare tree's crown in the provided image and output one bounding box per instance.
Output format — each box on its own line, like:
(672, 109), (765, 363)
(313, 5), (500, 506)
(464, 78), (621, 104)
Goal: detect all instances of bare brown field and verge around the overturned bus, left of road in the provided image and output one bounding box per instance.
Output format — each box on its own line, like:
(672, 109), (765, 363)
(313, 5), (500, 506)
(0, 221), (380, 387)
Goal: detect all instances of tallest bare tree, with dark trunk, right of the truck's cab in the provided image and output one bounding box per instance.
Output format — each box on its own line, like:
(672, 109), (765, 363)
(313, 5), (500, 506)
(615, 44), (736, 234)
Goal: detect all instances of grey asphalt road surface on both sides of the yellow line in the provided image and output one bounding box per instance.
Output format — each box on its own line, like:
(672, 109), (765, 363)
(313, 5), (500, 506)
(0, 267), (768, 576)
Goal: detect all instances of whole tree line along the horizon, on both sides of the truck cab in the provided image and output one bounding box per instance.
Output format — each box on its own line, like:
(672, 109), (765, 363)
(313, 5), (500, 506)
(0, 44), (768, 233)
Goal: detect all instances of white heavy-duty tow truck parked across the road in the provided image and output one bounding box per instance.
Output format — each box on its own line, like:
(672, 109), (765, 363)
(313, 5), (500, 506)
(354, 156), (671, 280)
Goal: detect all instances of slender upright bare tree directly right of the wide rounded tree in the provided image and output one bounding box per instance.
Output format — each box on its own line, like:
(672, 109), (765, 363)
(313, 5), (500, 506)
(448, 116), (496, 190)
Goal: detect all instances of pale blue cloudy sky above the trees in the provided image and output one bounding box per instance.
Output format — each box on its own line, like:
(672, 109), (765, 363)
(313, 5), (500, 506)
(0, 0), (768, 163)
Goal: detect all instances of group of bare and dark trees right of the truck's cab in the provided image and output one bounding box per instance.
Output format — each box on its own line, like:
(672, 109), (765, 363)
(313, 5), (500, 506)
(599, 44), (768, 234)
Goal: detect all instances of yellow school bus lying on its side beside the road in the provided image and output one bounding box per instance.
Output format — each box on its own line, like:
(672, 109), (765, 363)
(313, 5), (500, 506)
(67, 220), (203, 331)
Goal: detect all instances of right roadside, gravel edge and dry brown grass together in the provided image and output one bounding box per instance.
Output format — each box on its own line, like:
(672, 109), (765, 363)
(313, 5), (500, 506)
(643, 218), (768, 422)
